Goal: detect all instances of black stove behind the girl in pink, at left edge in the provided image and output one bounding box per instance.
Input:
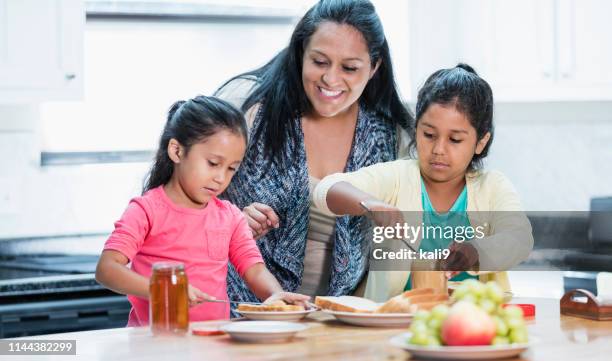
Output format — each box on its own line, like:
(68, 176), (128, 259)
(0, 255), (130, 338)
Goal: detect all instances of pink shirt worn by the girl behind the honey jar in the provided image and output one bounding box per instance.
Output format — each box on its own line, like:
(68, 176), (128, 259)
(104, 186), (263, 326)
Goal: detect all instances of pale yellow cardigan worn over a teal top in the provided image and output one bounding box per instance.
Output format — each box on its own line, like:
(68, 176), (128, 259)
(313, 159), (533, 301)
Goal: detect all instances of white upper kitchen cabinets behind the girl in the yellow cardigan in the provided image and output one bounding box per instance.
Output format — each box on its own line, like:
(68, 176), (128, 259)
(411, 0), (612, 101)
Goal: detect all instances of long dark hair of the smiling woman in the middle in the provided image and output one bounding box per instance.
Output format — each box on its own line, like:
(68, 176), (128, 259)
(215, 0), (413, 165)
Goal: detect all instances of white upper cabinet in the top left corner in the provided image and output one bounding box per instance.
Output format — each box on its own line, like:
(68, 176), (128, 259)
(0, 0), (85, 103)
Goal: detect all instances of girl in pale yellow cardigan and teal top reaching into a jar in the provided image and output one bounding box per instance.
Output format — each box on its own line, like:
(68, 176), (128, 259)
(313, 64), (533, 300)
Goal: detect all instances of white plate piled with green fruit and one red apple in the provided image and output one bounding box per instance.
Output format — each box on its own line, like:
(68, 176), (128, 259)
(391, 280), (530, 360)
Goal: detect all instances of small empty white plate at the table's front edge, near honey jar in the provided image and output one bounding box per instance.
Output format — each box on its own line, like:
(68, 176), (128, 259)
(220, 321), (308, 343)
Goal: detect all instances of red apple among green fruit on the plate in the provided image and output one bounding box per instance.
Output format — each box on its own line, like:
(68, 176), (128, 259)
(442, 301), (495, 346)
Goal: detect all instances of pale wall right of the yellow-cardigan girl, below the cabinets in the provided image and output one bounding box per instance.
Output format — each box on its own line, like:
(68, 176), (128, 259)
(487, 102), (612, 211)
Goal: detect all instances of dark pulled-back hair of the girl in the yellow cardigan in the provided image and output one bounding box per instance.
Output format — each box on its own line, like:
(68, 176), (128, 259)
(409, 63), (493, 170)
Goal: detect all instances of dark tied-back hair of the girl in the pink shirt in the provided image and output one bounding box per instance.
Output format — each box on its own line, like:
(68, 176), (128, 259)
(142, 95), (247, 193)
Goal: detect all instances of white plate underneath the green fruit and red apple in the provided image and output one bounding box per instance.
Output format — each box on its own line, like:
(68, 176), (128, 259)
(389, 332), (532, 360)
